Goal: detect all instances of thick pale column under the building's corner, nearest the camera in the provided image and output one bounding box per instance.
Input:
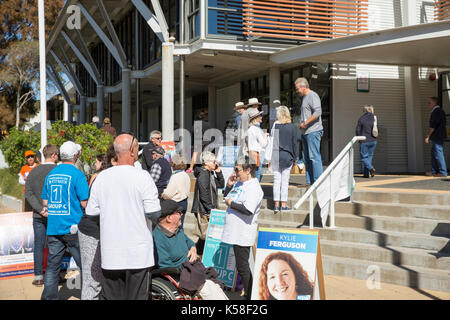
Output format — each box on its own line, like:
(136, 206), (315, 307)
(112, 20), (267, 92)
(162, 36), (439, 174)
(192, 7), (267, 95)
(162, 38), (175, 140)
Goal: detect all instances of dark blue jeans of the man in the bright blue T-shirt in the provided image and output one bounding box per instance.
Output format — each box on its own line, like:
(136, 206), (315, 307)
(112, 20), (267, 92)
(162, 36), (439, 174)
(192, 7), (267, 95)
(41, 234), (81, 300)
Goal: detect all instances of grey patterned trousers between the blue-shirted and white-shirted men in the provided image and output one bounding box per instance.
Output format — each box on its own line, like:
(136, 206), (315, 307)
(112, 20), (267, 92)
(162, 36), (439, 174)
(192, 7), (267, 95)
(78, 230), (103, 300)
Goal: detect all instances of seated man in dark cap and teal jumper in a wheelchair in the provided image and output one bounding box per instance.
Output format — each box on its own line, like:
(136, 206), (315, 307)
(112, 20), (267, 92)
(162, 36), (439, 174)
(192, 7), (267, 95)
(152, 200), (228, 300)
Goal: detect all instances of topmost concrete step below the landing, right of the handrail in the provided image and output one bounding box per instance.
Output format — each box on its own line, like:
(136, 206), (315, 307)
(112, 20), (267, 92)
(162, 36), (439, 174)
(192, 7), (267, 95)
(353, 188), (450, 206)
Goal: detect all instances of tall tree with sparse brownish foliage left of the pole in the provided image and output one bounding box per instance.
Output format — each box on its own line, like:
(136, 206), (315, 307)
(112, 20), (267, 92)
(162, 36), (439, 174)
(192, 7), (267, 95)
(0, 41), (39, 127)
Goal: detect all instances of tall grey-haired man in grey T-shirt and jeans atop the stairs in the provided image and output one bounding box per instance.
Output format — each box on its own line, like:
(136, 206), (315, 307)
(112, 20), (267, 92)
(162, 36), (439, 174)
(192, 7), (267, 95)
(295, 78), (323, 185)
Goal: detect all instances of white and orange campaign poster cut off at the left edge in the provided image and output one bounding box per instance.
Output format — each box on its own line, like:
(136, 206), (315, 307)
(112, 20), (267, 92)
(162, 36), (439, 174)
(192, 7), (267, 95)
(0, 212), (34, 279)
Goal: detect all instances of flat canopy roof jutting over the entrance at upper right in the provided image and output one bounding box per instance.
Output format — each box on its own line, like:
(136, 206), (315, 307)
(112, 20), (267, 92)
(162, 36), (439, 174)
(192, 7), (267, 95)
(270, 21), (450, 68)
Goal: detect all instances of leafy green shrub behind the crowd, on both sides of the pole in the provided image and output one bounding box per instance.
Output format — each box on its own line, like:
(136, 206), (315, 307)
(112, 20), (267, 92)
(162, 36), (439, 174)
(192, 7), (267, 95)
(0, 121), (113, 173)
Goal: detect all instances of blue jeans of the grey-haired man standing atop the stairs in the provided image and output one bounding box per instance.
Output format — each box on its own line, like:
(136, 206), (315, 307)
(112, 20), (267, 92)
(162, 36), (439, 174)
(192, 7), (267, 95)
(302, 130), (323, 185)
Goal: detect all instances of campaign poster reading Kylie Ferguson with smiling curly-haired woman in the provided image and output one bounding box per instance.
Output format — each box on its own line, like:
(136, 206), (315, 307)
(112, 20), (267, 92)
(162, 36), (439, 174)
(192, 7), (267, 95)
(251, 228), (319, 300)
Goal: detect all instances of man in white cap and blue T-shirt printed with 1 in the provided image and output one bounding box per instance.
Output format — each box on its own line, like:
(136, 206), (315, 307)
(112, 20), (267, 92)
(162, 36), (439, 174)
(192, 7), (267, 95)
(41, 141), (89, 300)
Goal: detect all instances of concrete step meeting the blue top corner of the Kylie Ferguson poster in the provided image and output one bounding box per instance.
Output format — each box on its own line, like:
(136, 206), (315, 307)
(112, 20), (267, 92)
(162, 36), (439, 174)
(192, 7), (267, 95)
(320, 239), (450, 271)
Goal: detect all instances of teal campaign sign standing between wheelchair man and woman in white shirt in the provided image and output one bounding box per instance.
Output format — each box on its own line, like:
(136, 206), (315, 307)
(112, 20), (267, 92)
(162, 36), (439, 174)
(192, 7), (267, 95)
(202, 209), (236, 288)
